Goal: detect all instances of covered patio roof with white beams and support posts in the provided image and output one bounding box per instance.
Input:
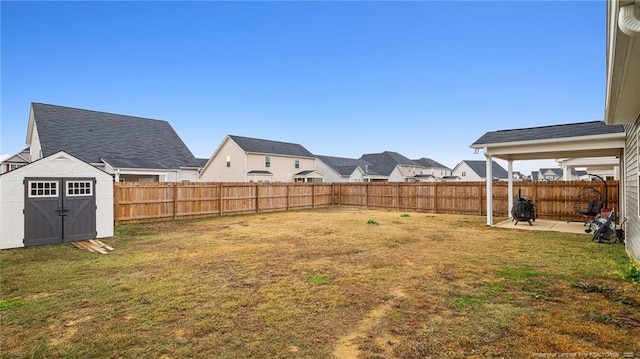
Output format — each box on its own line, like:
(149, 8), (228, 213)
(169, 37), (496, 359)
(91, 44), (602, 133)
(470, 121), (626, 226)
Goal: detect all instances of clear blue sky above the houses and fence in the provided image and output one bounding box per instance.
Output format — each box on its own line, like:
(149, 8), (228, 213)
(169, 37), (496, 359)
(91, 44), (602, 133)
(0, 1), (606, 173)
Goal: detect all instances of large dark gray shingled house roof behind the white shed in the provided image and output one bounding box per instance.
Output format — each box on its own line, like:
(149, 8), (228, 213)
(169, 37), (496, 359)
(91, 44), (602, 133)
(31, 103), (199, 169)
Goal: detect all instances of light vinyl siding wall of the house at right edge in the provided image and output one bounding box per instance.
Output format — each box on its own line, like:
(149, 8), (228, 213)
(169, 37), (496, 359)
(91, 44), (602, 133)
(623, 119), (640, 261)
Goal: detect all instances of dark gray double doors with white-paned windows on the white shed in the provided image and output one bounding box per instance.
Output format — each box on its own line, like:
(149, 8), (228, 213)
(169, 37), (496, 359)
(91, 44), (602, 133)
(24, 178), (96, 246)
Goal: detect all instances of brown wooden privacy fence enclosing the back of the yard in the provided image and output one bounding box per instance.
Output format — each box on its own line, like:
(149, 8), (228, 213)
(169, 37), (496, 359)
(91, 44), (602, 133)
(114, 181), (619, 224)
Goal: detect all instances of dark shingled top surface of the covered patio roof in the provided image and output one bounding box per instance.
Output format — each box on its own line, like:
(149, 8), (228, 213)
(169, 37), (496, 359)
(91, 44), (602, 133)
(471, 121), (624, 147)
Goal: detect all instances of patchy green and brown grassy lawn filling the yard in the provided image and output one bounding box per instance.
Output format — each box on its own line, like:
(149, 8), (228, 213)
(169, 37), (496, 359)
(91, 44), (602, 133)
(0, 208), (640, 359)
